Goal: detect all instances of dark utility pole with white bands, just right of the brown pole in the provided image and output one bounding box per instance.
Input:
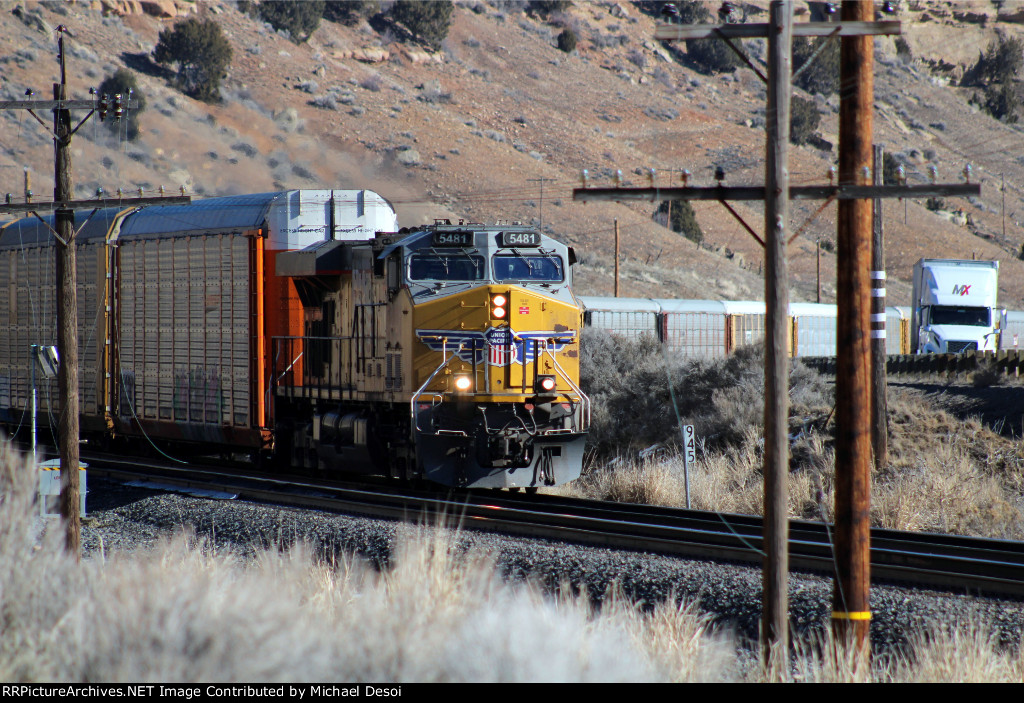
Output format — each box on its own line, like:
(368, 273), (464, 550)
(871, 145), (889, 469)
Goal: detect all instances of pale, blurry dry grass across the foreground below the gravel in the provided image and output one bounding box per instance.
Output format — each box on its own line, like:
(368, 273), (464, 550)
(0, 443), (1024, 683)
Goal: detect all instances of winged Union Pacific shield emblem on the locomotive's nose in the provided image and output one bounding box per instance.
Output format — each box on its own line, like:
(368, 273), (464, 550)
(416, 327), (575, 366)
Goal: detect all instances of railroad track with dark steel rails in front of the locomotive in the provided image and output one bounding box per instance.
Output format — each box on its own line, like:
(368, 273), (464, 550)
(83, 457), (1024, 598)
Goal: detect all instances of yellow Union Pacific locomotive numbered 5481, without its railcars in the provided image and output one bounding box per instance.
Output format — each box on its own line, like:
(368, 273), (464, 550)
(271, 216), (590, 488)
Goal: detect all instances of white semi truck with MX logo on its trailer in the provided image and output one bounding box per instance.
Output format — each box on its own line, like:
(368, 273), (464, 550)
(910, 259), (1007, 354)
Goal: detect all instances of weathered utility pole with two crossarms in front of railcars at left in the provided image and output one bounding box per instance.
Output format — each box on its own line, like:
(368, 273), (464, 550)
(0, 25), (190, 558)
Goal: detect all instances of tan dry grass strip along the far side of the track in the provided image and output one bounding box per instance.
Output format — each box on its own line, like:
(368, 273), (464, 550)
(559, 397), (1024, 539)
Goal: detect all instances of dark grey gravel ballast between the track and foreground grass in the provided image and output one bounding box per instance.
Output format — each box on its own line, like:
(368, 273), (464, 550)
(82, 477), (1024, 653)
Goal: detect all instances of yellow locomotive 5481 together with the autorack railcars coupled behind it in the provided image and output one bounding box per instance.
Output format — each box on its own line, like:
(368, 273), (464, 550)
(0, 190), (590, 488)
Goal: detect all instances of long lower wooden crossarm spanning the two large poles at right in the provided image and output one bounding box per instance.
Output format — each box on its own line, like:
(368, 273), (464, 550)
(573, 183), (981, 202)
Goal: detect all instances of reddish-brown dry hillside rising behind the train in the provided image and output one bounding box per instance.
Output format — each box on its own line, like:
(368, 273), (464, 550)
(6, 0), (1024, 309)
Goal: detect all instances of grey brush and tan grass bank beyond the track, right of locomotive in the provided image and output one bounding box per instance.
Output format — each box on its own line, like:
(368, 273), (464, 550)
(573, 338), (1024, 539)
